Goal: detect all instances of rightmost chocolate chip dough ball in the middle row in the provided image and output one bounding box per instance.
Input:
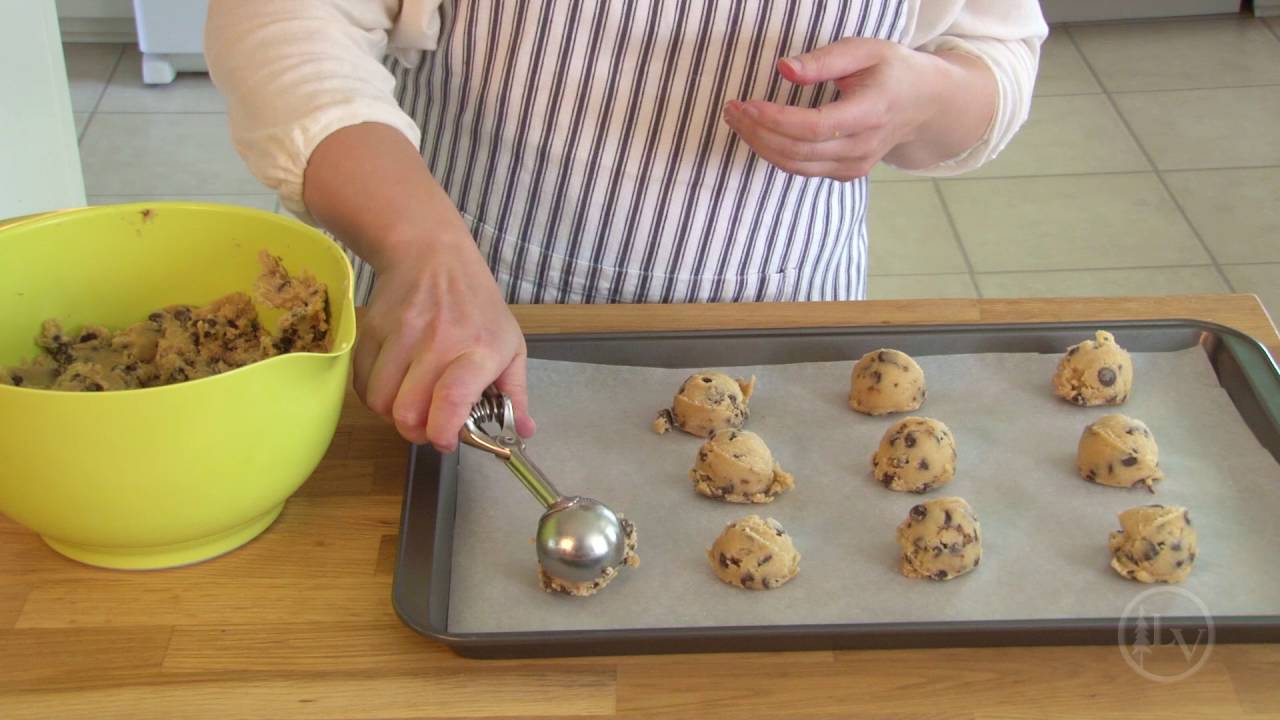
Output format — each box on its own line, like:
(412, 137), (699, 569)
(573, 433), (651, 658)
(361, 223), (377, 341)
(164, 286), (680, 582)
(1075, 415), (1165, 492)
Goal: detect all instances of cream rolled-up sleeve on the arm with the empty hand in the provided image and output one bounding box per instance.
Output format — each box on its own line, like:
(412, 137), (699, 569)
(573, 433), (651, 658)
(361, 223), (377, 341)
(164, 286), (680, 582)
(905, 0), (1048, 177)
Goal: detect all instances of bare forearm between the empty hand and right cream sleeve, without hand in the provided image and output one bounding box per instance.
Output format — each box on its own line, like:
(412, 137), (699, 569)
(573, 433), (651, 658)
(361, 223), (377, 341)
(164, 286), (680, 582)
(884, 53), (1000, 170)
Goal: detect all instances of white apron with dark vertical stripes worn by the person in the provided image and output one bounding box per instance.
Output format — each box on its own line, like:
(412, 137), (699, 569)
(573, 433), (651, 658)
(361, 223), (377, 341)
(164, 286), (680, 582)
(357, 0), (906, 302)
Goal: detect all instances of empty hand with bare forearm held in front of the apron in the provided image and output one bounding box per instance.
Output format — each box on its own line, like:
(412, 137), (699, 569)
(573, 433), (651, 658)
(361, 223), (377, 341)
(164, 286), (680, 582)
(724, 37), (998, 181)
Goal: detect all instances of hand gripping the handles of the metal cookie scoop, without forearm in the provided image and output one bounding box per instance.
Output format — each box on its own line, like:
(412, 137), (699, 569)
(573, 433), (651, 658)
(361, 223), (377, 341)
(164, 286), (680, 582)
(355, 237), (534, 451)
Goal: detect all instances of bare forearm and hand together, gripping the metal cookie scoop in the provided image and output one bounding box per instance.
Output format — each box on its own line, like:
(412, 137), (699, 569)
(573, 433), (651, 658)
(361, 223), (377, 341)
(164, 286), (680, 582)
(303, 123), (534, 451)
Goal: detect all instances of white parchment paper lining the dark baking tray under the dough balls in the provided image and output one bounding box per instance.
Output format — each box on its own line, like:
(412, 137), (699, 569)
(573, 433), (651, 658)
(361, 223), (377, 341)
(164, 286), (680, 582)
(448, 347), (1280, 633)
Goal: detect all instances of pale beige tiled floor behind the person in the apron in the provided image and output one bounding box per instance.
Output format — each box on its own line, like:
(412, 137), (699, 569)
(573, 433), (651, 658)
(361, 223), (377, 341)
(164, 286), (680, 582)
(67, 17), (1280, 318)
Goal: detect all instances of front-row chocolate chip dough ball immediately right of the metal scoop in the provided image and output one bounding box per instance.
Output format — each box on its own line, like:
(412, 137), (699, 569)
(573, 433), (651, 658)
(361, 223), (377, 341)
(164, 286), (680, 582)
(707, 515), (800, 591)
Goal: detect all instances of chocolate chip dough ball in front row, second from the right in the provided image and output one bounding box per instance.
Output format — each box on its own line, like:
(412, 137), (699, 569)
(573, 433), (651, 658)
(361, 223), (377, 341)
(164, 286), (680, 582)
(897, 497), (982, 580)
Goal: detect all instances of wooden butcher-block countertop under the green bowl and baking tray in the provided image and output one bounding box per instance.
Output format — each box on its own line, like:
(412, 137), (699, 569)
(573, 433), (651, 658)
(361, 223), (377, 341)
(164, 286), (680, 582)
(0, 296), (1280, 720)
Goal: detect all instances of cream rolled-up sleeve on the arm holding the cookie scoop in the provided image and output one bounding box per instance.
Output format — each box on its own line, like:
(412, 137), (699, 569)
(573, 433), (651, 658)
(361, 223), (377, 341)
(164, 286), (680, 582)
(205, 0), (420, 219)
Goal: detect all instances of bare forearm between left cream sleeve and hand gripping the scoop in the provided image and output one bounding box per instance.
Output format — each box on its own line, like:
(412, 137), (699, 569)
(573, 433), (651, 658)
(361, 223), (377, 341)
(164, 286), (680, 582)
(302, 123), (475, 272)
